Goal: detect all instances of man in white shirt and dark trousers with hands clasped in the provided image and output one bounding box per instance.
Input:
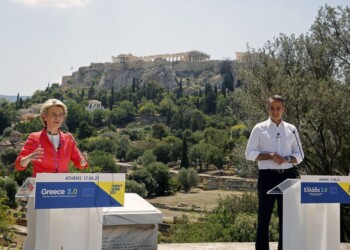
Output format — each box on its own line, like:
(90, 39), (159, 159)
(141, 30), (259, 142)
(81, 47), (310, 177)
(245, 95), (303, 250)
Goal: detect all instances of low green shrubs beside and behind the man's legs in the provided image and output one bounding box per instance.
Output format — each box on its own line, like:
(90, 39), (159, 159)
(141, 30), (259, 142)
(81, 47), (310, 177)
(169, 193), (278, 243)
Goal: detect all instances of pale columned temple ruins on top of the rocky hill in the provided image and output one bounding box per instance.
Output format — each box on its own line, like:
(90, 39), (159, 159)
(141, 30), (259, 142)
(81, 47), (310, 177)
(112, 50), (210, 63)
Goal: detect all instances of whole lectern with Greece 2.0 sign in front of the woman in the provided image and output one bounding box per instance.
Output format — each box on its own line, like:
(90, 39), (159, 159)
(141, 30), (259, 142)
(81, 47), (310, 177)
(16, 173), (125, 250)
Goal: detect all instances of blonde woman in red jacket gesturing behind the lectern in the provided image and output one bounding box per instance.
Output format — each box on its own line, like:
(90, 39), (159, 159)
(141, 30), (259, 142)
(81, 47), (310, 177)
(16, 99), (89, 250)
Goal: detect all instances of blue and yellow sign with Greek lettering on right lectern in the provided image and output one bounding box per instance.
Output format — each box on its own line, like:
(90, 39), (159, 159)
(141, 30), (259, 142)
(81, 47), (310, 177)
(301, 175), (350, 203)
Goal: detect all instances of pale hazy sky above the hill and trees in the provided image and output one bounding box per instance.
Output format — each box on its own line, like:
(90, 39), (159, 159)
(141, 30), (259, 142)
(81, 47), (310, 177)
(0, 0), (349, 96)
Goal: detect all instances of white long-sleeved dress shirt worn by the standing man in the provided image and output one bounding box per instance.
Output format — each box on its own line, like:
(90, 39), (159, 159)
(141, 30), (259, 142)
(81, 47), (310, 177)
(245, 118), (304, 169)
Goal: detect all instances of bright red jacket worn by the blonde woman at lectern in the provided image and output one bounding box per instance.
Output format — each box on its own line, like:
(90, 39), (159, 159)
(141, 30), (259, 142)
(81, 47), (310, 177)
(15, 129), (89, 177)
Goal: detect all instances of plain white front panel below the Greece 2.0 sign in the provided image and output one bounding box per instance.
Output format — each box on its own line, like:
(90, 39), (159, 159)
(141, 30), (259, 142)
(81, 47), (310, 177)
(35, 205), (103, 250)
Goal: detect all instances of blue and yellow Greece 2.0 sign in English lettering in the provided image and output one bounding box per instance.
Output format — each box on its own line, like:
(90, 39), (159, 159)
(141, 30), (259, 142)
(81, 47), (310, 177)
(35, 173), (125, 209)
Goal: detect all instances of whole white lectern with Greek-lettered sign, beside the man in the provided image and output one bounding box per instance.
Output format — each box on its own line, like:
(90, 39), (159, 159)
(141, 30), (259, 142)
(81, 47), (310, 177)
(268, 176), (350, 250)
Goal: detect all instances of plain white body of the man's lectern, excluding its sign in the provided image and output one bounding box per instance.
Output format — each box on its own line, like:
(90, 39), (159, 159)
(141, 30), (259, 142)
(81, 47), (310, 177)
(268, 179), (340, 250)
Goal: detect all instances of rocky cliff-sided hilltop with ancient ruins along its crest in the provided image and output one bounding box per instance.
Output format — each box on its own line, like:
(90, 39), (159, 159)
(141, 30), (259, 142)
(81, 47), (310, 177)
(62, 51), (237, 93)
